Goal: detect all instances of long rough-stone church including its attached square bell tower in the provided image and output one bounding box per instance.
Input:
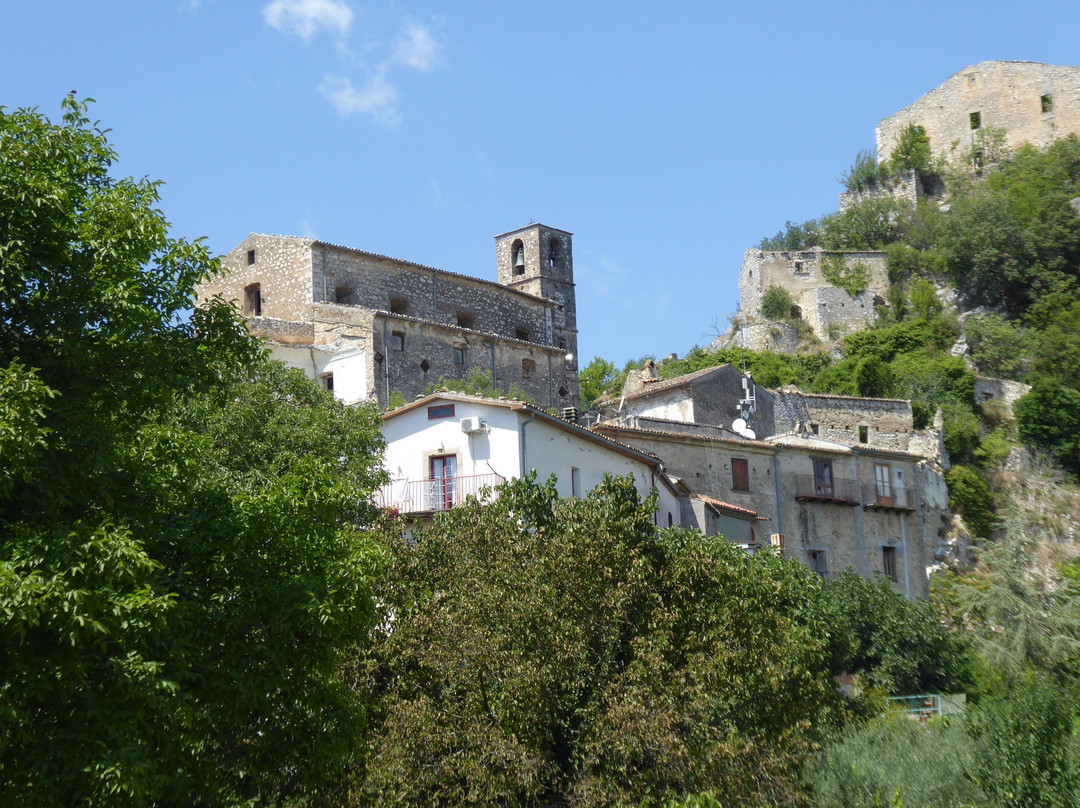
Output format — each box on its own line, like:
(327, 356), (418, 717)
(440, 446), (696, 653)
(199, 225), (579, 409)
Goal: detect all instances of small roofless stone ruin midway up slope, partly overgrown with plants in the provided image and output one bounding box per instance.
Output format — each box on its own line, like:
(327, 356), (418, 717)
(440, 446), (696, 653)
(739, 247), (889, 353)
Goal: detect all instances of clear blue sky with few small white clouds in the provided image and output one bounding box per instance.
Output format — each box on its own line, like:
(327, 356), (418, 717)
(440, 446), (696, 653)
(0, 0), (1080, 365)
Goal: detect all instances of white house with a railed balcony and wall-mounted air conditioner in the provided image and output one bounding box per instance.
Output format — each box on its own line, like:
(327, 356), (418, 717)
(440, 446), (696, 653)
(377, 393), (683, 527)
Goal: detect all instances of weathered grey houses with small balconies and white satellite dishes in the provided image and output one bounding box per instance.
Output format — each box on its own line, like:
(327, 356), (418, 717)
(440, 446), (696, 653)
(595, 365), (949, 596)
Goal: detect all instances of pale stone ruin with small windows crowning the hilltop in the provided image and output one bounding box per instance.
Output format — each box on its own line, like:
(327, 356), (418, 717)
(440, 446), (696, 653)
(875, 62), (1080, 163)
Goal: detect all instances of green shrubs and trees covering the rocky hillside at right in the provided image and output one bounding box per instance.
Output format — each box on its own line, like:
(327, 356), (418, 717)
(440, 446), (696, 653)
(583, 127), (1080, 808)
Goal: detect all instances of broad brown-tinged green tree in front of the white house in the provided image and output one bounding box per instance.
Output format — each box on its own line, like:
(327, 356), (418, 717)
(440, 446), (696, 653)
(365, 479), (832, 806)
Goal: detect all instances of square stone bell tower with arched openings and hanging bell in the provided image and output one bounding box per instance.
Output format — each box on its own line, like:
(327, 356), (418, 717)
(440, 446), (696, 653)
(495, 224), (578, 368)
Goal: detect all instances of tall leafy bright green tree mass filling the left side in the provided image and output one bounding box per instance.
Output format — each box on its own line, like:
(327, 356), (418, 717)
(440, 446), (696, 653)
(0, 97), (379, 805)
